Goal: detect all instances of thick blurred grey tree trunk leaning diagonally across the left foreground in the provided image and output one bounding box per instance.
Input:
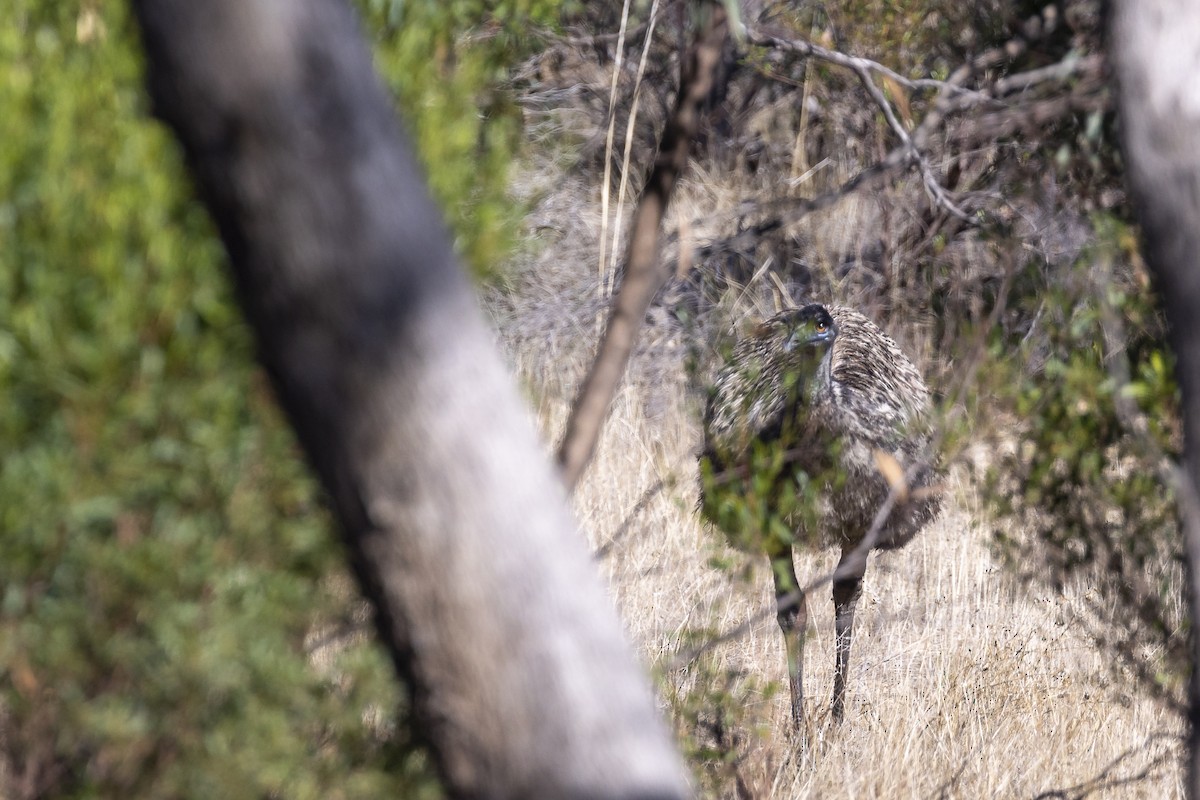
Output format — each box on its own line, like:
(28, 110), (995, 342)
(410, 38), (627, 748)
(133, 0), (686, 798)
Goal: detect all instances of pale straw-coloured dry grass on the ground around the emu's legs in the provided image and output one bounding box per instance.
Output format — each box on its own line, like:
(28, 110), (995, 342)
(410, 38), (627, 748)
(528, 359), (1183, 798)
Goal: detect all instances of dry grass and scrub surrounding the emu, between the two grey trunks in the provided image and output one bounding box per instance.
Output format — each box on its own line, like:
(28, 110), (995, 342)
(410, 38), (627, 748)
(488, 1), (1184, 798)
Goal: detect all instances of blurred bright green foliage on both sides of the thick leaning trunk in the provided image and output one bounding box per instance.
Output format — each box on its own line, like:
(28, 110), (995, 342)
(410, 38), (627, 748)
(0, 0), (576, 798)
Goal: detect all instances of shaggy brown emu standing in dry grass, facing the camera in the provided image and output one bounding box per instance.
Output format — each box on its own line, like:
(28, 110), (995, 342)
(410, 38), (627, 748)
(701, 303), (940, 732)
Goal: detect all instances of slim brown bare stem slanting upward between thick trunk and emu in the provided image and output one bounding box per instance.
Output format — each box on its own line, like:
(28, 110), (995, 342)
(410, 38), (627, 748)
(558, 4), (728, 488)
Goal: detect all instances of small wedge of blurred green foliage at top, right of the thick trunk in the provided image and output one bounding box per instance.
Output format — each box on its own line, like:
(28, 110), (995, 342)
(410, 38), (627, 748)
(359, 0), (563, 276)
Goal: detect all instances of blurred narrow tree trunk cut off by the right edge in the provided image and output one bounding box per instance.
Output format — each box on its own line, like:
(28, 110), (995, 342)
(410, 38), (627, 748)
(1111, 0), (1200, 798)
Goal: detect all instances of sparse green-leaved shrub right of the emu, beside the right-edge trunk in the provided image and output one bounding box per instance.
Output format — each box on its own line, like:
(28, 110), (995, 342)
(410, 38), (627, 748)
(986, 217), (1188, 694)
